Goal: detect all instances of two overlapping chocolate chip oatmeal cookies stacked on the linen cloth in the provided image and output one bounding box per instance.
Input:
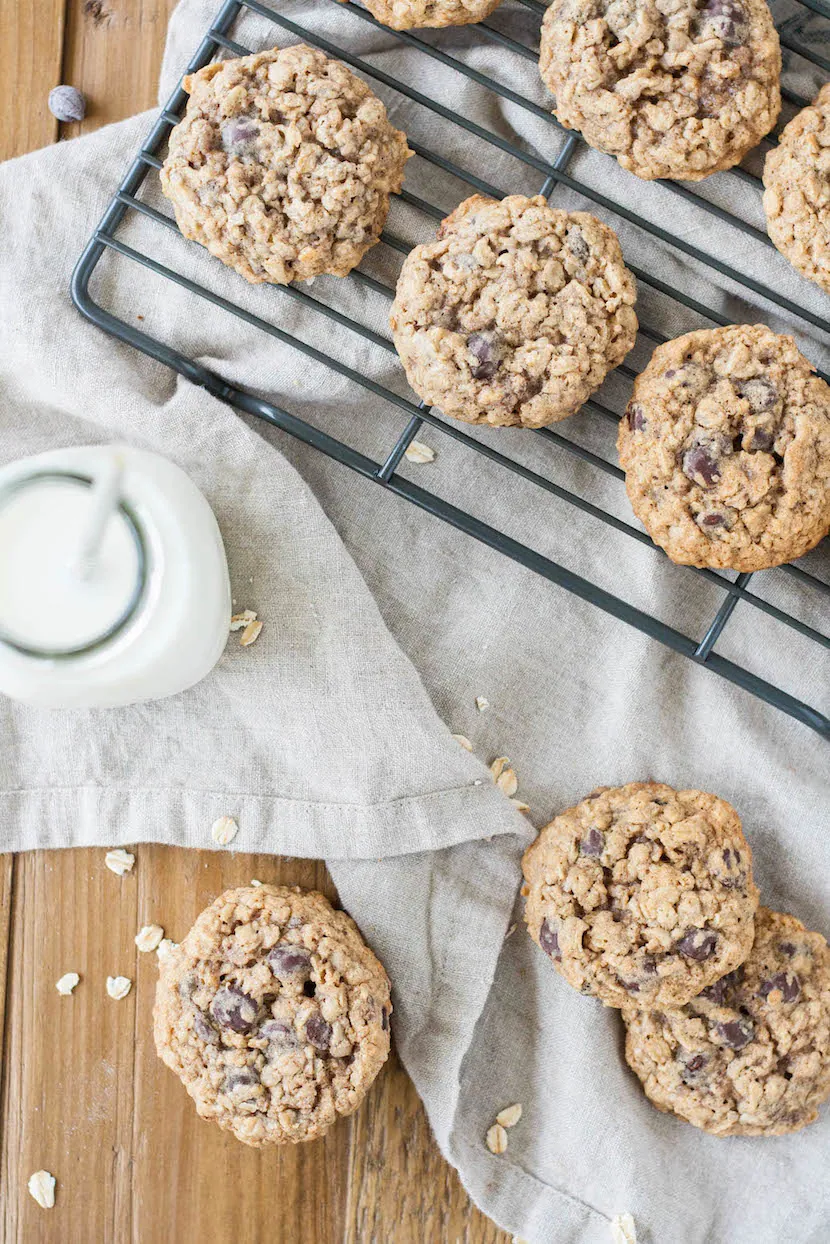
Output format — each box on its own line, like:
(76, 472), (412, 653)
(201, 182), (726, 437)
(523, 782), (830, 1136)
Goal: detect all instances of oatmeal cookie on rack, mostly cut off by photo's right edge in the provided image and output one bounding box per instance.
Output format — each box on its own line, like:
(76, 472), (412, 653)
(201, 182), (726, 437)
(764, 82), (830, 294)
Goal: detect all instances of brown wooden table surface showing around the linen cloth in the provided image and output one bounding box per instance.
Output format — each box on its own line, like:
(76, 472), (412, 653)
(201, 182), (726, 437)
(0, 0), (509, 1244)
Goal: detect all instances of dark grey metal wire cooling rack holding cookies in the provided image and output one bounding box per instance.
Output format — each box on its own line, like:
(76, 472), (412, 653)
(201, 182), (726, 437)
(72, 0), (830, 739)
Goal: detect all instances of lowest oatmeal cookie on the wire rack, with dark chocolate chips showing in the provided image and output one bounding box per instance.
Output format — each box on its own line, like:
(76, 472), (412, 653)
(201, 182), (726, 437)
(617, 325), (830, 571)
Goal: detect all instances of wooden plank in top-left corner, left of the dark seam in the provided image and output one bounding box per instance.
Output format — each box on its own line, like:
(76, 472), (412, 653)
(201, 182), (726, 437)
(0, 0), (65, 159)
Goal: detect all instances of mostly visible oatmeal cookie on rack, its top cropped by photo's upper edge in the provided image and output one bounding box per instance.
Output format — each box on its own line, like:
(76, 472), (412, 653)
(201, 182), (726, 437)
(540, 0), (781, 182)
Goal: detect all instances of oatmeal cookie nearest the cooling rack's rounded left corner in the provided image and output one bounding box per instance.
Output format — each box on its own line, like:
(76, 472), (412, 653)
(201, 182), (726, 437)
(161, 45), (412, 285)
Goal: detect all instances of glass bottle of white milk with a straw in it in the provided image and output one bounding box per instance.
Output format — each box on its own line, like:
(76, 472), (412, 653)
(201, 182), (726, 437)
(0, 445), (230, 708)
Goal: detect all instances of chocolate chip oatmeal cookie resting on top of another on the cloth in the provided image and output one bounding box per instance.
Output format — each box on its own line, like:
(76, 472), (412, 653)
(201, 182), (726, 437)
(523, 781), (758, 1008)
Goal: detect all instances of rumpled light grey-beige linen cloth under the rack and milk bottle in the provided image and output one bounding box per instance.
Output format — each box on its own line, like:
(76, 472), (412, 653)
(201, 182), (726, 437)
(0, 0), (830, 1244)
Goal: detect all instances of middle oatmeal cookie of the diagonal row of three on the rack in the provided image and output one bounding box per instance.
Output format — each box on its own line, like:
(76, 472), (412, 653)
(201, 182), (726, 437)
(391, 194), (637, 428)
